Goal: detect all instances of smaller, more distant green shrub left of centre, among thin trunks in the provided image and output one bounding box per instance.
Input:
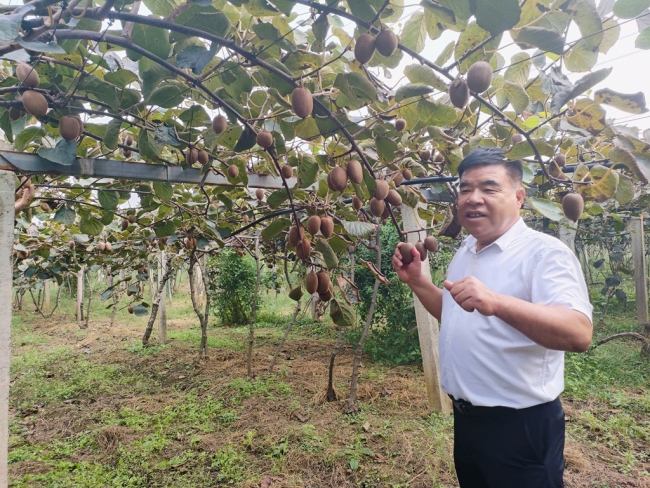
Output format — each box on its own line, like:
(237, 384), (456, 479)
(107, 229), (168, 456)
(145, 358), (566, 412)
(206, 249), (259, 325)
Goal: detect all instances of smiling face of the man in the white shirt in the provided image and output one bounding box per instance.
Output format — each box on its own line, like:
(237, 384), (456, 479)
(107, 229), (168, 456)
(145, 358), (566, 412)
(458, 164), (526, 247)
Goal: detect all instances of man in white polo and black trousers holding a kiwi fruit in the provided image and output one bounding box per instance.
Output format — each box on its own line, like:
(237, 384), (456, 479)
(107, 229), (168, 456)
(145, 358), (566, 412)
(392, 147), (592, 488)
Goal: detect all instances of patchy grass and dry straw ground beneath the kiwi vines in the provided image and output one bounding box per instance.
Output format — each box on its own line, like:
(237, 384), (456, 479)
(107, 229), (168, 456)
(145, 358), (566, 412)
(9, 276), (650, 488)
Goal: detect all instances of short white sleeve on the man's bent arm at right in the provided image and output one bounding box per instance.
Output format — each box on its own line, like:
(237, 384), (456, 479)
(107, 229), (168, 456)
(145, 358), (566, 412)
(531, 245), (593, 324)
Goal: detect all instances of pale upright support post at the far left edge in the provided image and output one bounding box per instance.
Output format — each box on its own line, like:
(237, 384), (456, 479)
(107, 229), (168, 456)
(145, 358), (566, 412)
(0, 171), (16, 487)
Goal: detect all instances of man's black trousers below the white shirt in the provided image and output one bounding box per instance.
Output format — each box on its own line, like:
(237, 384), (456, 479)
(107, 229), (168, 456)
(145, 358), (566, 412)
(454, 398), (564, 488)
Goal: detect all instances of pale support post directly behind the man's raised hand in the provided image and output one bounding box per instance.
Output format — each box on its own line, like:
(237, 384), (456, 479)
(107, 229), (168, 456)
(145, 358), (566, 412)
(402, 204), (452, 413)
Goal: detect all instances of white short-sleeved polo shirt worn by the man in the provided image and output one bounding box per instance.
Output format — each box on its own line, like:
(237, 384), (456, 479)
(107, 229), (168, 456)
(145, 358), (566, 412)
(440, 219), (593, 408)
